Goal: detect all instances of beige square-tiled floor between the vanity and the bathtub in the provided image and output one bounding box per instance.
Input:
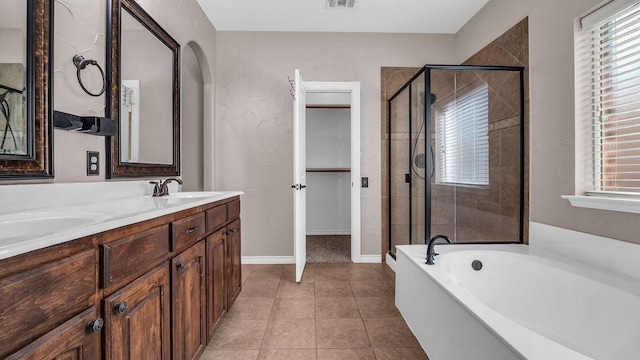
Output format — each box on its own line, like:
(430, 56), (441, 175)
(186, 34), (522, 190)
(201, 264), (428, 360)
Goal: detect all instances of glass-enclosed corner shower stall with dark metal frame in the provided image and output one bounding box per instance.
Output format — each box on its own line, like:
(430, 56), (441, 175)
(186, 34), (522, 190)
(386, 65), (525, 258)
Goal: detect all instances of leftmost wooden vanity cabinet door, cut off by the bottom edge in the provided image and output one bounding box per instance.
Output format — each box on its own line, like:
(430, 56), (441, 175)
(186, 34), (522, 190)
(6, 306), (103, 360)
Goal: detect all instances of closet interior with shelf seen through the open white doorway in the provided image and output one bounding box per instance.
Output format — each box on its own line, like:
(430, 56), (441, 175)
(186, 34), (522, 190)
(305, 92), (352, 264)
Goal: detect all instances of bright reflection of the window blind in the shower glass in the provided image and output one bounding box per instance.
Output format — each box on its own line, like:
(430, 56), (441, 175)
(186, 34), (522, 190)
(436, 83), (489, 185)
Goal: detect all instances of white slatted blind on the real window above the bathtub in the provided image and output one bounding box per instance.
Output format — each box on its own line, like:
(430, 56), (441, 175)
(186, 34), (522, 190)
(576, 0), (640, 194)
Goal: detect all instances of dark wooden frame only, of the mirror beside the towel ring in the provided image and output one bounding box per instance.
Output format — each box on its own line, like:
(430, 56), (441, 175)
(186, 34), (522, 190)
(106, 0), (180, 178)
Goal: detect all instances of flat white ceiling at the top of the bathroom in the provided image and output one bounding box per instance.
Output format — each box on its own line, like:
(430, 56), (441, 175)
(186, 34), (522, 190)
(197, 0), (489, 34)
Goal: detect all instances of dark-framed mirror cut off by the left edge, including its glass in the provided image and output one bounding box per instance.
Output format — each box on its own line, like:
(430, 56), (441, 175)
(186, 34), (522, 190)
(0, 0), (53, 179)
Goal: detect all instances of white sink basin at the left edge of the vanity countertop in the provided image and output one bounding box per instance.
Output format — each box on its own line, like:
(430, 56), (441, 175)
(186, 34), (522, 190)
(0, 212), (107, 240)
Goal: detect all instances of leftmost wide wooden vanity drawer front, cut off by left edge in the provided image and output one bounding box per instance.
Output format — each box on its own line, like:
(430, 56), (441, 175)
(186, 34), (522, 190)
(0, 250), (97, 359)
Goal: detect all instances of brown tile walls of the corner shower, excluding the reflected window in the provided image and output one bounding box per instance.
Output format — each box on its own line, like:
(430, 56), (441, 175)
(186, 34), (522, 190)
(381, 19), (529, 252)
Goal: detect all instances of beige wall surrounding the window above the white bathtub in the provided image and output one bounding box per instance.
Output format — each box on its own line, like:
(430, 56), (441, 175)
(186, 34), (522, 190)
(456, 0), (640, 243)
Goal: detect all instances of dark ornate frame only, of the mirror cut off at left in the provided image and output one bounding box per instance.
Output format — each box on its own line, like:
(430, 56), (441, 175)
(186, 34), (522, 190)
(0, 0), (53, 180)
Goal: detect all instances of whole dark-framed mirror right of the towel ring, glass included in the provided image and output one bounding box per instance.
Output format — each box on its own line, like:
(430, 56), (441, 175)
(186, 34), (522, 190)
(107, 0), (180, 178)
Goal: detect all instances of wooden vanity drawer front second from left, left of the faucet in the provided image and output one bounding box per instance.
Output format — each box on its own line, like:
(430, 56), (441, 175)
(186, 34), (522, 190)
(100, 224), (169, 288)
